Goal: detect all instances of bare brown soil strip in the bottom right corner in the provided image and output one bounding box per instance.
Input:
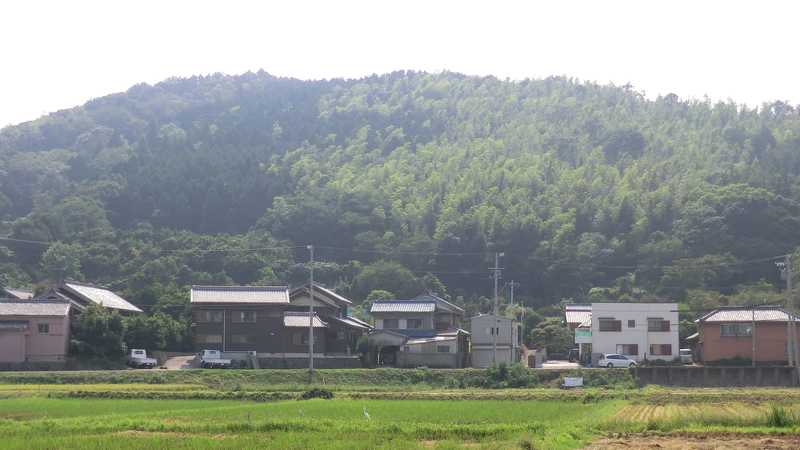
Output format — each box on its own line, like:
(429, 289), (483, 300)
(585, 433), (800, 450)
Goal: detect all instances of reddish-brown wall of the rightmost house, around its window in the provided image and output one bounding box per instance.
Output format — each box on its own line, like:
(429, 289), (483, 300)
(700, 322), (800, 363)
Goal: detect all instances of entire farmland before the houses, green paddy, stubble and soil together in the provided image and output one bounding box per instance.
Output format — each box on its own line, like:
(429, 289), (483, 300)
(0, 373), (800, 449)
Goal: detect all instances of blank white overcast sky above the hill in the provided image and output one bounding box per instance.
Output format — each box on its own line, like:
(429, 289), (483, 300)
(0, 0), (800, 126)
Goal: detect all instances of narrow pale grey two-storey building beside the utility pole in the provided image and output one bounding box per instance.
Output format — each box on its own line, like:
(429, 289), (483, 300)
(470, 314), (520, 367)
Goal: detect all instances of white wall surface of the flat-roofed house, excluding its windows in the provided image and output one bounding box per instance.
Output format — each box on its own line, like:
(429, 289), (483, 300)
(592, 303), (680, 361)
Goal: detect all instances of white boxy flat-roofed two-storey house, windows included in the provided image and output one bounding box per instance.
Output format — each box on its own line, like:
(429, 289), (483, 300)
(590, 303), (679, 361)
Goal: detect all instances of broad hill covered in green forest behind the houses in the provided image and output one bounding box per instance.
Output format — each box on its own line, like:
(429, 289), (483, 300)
(0, 72), (800, 312)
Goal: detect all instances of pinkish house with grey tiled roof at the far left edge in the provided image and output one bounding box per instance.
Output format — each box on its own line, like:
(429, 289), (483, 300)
(0, 300), (70, 363)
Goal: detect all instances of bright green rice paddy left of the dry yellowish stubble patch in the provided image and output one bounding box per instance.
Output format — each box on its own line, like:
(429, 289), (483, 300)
(0, 397), (622, 449)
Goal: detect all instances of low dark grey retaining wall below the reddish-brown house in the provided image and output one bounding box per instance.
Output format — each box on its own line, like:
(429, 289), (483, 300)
(633, 366), (796, 387)
